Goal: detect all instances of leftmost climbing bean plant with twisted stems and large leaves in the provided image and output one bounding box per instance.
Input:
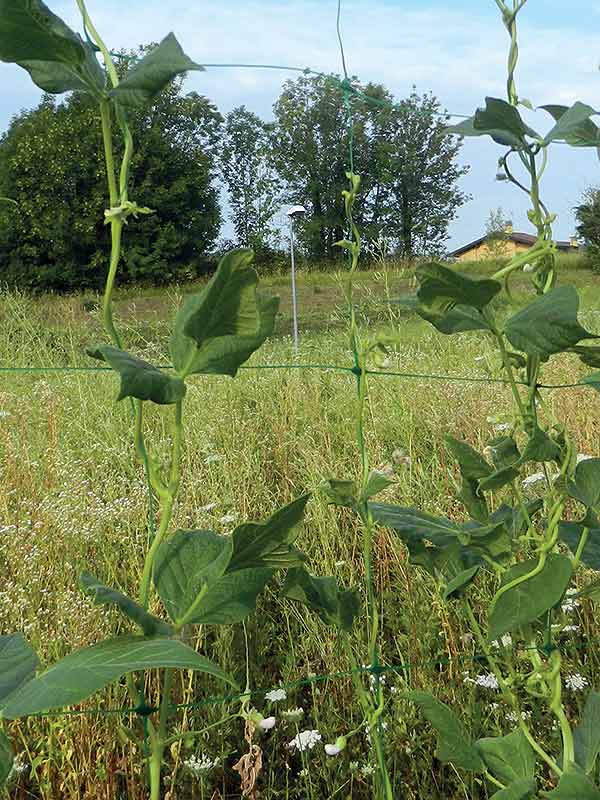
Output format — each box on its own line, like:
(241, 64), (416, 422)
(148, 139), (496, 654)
(0, 0), (356, 800)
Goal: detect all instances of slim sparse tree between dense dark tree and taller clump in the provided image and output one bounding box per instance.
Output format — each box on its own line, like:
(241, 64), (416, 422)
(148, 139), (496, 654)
(221, 106), (279, 250)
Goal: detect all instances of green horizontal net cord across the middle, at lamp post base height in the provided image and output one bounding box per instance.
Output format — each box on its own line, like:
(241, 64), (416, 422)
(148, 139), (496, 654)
(0, 364), (591, 389)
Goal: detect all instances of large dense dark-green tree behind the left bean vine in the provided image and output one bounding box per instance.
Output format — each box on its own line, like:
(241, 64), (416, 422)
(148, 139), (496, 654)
(0, 47), (221, 291)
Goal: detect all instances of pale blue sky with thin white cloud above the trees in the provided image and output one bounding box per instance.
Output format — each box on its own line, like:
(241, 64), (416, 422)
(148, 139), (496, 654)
(0, 0), (600, 250)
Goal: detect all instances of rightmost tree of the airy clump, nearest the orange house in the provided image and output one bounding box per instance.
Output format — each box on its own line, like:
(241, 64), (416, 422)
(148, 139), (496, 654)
(378, 91), (469, 258)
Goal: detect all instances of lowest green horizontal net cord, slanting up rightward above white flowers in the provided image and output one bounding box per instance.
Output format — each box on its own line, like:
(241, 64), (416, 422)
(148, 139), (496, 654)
(28, 637), (600, 719)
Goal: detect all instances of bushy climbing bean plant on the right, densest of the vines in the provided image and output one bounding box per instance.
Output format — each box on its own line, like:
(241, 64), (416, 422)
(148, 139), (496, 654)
(369, 0), (600, 800)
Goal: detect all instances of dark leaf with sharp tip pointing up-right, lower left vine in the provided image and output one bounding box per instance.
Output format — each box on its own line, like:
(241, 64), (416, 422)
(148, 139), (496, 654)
(229, 494), (310, 572)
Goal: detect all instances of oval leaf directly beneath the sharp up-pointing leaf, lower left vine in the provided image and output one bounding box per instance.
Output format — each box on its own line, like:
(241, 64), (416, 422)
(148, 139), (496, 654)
(179, 567), (274, 625)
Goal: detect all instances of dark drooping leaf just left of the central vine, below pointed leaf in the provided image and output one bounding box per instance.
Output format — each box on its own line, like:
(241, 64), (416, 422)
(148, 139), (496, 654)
(281, 567), (360, 631)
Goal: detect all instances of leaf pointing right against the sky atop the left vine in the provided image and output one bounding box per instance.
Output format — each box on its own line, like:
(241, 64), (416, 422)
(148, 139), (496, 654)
(110, 33), (204, 109)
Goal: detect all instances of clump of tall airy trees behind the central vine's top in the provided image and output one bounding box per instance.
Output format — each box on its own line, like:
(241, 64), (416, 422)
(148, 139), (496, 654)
(273, 76), (468, 259)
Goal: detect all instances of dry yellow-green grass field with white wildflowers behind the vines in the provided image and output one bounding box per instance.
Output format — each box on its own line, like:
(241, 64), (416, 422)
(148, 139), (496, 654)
(0, 260), (600, 800)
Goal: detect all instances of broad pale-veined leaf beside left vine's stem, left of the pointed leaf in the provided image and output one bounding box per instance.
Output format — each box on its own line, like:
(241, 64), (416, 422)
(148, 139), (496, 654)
(153, 531), (233, 625)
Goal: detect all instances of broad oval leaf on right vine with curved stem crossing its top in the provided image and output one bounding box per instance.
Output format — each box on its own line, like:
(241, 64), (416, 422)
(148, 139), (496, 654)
(488, 553), (573, 642)
